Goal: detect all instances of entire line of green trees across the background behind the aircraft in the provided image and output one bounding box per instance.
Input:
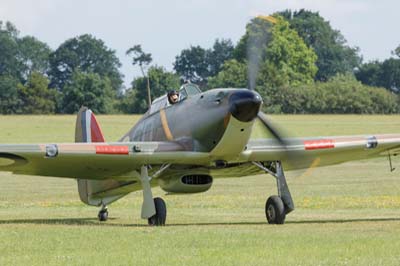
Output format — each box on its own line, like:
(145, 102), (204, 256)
(0, 10), (400, 114)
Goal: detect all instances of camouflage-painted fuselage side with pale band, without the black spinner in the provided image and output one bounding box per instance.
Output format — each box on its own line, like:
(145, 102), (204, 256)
(121, 89), (252, 152)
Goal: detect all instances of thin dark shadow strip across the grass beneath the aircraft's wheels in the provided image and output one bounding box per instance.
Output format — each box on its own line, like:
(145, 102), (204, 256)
(0, 217), (400, 227)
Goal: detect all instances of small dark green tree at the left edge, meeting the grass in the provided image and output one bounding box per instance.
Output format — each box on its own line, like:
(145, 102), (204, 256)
(0, 75), (21, 114)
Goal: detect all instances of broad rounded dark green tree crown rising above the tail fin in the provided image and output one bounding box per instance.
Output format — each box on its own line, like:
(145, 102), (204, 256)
(49, 34), (122, 91)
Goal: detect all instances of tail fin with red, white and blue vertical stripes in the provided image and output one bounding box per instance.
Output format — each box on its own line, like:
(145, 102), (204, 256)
(75, 107), (105, 142)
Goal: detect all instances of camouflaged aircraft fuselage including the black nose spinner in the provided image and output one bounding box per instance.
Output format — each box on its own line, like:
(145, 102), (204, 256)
(121, 84), (262, 157)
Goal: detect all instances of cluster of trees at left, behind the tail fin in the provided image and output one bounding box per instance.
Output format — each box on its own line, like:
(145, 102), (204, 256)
(0, 21), (122, 114)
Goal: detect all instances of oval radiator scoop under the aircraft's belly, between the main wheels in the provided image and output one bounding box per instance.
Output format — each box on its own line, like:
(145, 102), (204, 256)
(159, 174), (213, 193)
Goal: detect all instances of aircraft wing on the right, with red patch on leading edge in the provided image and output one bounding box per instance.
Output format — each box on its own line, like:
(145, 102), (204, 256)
(242, 134), (400, 170)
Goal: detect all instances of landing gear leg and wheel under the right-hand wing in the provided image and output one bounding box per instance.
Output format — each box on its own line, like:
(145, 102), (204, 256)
(253, 161), (294, 224)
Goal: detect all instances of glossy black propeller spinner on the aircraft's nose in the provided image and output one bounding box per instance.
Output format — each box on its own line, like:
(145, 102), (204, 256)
(229, 90), (262, 122)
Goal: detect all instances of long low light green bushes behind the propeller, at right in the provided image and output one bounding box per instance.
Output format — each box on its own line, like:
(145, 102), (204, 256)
(267, 74), (399, 114)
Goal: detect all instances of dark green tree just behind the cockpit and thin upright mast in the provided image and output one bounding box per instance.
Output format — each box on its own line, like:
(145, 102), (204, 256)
(119, 66), (180, 113)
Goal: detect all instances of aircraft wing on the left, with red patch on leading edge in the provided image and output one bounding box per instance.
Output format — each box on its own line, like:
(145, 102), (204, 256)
(0, 142), (208, 180)
